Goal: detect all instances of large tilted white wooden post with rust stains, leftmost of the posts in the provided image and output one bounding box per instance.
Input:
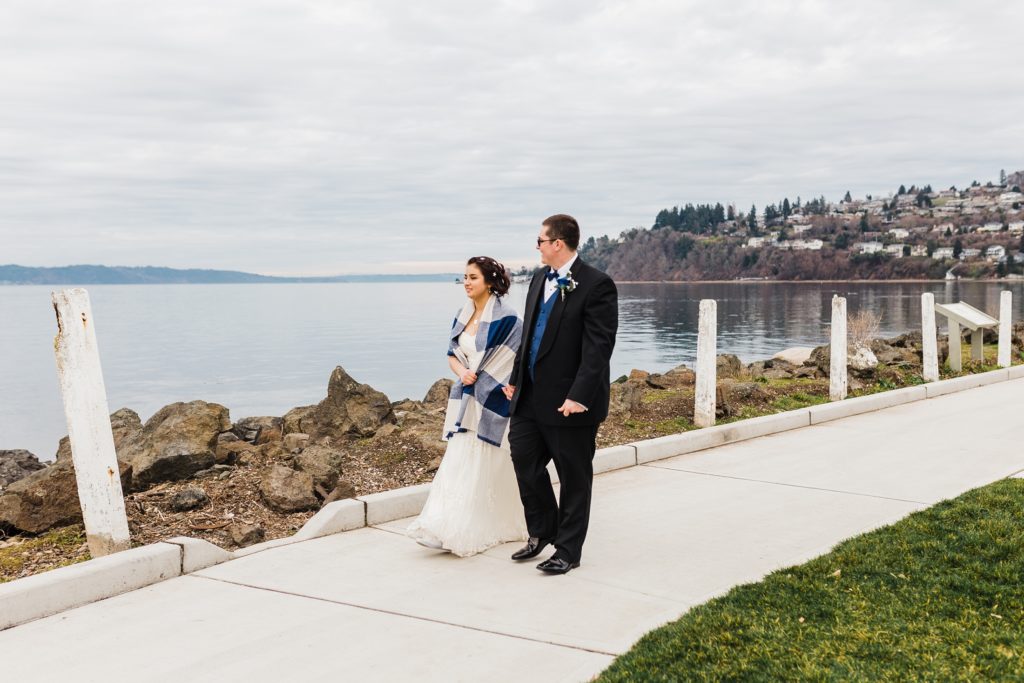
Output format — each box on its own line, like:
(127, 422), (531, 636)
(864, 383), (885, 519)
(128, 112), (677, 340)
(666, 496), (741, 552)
(52, 289), (131, 557)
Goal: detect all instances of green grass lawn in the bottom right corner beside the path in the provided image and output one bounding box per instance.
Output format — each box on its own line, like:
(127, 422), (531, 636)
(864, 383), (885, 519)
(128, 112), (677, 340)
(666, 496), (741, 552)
(598, 479), (1024, 681)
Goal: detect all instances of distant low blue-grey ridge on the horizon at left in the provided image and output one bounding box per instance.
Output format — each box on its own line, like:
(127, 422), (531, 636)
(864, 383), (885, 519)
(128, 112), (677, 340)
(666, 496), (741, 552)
(0, 264), (459, 285)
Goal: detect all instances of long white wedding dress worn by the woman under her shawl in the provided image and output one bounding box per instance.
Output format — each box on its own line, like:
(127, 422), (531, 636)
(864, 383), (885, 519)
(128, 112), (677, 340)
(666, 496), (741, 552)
(408, 333), (527, 557)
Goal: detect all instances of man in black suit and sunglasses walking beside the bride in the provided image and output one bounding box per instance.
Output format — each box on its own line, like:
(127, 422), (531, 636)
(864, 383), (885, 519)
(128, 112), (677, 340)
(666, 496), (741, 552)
(505, 214), (618, 573)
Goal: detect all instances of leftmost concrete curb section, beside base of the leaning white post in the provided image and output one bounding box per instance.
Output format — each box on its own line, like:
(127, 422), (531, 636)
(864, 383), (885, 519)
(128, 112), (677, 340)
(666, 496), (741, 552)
(0, 543), (180, 631)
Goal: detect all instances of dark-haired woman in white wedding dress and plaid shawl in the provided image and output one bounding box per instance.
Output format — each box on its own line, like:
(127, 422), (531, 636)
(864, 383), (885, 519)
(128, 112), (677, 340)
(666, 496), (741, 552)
(408, 256), (527, 557)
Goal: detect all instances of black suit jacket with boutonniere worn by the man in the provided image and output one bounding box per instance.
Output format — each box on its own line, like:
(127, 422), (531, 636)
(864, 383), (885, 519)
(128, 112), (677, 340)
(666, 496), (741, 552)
(509, 258), (618, 426)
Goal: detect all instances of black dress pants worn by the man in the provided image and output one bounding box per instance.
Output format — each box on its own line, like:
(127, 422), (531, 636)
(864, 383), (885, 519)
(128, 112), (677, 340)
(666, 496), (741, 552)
(509, 381), (597, 562)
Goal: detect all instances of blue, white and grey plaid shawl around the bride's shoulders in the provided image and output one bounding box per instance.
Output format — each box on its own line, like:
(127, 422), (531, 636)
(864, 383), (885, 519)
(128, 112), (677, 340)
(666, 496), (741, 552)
(444, 295), (522, 446)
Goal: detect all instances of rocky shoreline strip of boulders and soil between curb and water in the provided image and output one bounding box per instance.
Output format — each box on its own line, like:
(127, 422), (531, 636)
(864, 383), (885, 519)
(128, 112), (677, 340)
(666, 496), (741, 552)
(0, 323), (1024, 582)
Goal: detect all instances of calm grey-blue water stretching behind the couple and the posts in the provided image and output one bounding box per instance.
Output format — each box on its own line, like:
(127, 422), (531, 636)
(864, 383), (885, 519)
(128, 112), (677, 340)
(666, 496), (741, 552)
(0, 283), (1024, 459)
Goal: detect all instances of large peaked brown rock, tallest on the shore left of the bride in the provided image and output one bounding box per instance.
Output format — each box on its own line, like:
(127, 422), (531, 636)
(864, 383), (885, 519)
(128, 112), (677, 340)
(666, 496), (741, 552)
(294, 366), (396, 440)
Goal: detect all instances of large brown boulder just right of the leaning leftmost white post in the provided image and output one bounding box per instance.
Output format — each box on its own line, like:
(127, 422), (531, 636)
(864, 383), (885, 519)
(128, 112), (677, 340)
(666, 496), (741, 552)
(123, 400), (231, 490)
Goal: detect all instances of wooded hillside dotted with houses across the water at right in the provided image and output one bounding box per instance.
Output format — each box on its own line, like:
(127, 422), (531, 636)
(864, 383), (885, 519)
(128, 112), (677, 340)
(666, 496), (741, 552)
(581, 171), (1024, 281)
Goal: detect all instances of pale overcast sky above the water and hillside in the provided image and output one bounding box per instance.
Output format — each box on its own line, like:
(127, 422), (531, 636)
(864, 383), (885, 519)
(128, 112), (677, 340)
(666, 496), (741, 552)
(0, 0), (1024, 274)
